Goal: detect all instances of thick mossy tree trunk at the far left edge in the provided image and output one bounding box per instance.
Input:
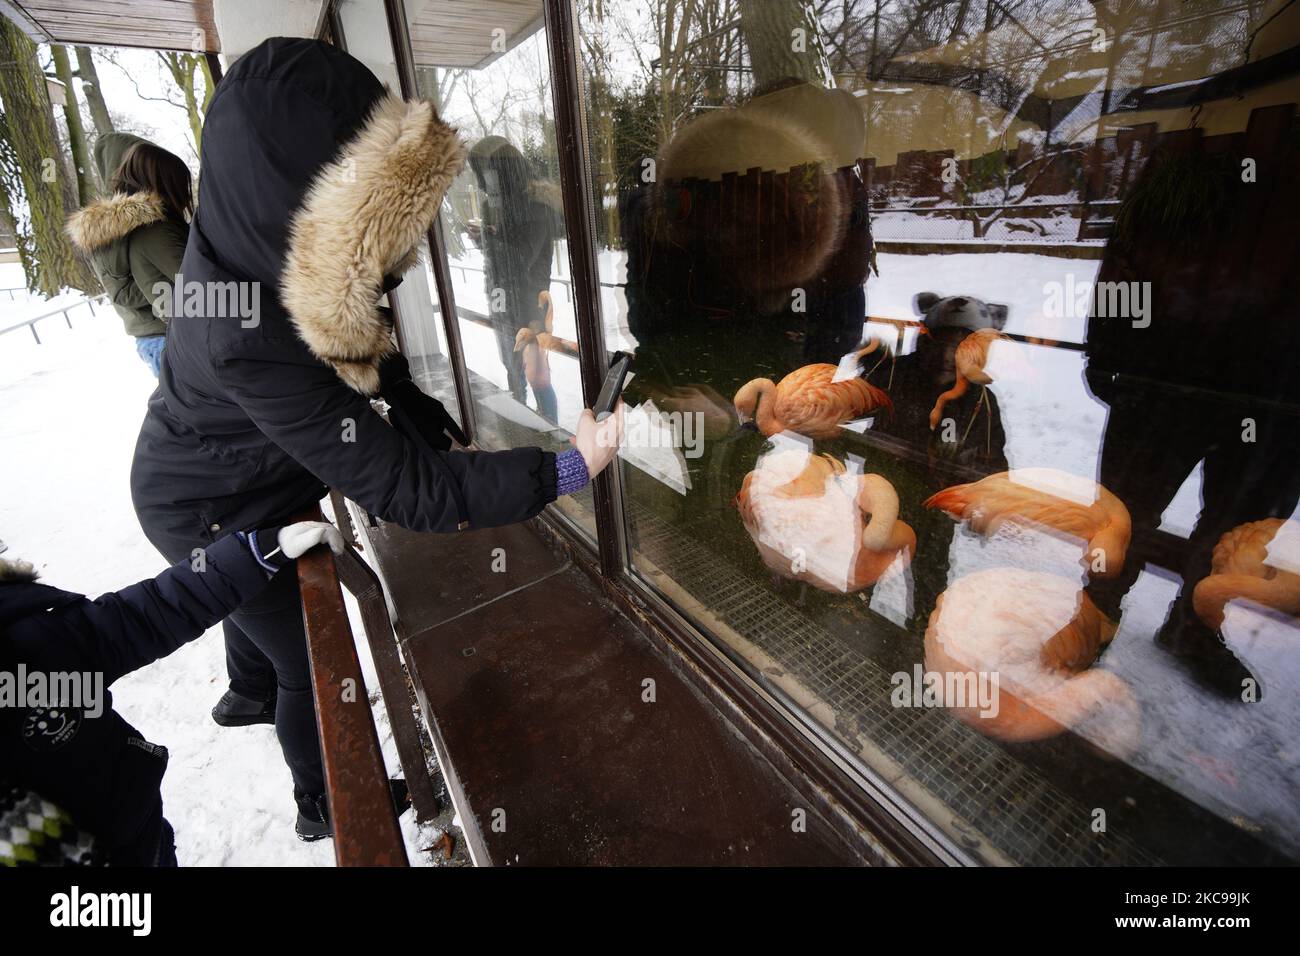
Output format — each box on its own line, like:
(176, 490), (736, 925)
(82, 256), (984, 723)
(0, 17), (100, 295)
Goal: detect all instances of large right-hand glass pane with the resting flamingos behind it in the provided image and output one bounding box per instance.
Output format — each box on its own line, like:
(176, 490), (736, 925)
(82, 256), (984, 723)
(579, 0), (1300, 864)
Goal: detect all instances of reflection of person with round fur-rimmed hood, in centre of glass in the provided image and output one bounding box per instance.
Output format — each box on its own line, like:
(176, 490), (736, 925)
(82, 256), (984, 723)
(623, 79), (871, 429)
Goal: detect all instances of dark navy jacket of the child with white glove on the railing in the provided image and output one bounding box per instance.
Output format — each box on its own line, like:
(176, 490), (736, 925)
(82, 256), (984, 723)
(0, 536), (268, 865)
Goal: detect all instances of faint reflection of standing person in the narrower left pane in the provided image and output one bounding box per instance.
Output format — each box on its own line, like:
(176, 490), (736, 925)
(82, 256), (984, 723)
(469, 137), (560, 421)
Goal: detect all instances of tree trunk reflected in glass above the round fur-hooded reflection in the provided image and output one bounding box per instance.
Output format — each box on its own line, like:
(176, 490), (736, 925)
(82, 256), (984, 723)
(740, 0), (835, 90)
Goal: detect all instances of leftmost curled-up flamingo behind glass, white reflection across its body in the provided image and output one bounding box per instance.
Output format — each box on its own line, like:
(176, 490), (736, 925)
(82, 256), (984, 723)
(735, 450), (917, 593)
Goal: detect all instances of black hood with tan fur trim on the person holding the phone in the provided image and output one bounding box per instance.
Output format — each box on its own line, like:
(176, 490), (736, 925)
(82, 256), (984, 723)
(195, 36), (464, 395)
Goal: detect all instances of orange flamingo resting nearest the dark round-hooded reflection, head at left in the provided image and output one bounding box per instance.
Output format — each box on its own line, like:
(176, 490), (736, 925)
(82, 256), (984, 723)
(733, 338), (893, 438)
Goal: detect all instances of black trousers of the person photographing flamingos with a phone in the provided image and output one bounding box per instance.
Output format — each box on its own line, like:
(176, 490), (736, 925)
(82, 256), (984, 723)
(139, 514), (325, 793)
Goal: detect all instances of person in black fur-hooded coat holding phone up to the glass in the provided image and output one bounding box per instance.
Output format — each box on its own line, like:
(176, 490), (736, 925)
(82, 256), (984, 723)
(131, 38), (621, 839)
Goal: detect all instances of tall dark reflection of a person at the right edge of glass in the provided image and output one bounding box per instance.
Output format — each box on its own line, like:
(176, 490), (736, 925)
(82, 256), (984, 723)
(1087, 127), (1300, 697)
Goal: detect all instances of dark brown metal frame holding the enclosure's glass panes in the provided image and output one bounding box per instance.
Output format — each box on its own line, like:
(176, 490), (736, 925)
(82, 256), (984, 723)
(374, 0), (978, 866)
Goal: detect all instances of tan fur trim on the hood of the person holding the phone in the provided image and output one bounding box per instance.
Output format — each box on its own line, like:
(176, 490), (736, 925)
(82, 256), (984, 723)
(280, 92), (465, 394)
